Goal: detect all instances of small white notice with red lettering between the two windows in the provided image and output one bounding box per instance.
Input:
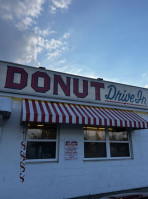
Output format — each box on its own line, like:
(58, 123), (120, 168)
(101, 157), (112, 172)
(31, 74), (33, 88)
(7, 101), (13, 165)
(64, 140), (78, 160)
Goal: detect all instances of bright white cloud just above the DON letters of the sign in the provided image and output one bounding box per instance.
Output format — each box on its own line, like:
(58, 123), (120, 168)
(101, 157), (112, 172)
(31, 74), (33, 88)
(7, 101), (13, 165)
(12, 30), (67, 65)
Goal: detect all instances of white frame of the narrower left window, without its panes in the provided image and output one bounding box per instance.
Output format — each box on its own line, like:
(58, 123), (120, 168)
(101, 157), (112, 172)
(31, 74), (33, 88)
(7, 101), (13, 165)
(25, 123), (59, 163)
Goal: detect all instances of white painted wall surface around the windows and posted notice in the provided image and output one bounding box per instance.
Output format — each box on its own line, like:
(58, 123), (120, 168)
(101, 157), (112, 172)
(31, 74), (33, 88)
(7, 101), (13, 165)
(0, 99), (148, 199)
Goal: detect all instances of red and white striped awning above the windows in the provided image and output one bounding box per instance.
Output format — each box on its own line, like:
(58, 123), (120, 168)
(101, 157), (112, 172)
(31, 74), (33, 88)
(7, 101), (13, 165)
(22, 100), (148, 129)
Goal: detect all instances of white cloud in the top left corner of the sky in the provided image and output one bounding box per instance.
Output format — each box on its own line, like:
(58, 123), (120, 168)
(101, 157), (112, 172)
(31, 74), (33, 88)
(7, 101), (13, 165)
(0, 0), (45, 30)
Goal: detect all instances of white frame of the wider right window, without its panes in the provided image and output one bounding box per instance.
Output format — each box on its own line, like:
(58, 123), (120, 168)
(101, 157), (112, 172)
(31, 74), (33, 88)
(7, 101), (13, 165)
(83, 126), (133, 161)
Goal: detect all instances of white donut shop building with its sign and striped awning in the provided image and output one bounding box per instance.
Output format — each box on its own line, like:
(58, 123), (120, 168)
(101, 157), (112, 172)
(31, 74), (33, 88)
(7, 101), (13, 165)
(0, 61), (148, 199)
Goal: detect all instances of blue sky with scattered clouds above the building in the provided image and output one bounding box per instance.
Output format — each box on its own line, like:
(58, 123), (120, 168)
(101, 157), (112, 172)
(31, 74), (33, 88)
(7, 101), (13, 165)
(0, 0), (148, 87)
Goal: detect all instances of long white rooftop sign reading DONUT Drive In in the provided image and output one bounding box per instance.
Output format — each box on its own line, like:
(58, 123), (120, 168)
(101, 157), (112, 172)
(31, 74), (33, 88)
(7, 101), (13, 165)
(0, 61), (148, 110)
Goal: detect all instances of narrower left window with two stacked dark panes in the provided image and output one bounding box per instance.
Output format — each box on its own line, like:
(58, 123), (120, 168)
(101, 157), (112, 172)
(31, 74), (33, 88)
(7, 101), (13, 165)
(26, 123), (57, 160)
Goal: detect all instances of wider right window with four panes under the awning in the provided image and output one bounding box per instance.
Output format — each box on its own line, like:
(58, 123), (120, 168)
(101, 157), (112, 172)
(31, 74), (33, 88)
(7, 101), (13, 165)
(84, 127), (131, 159)
